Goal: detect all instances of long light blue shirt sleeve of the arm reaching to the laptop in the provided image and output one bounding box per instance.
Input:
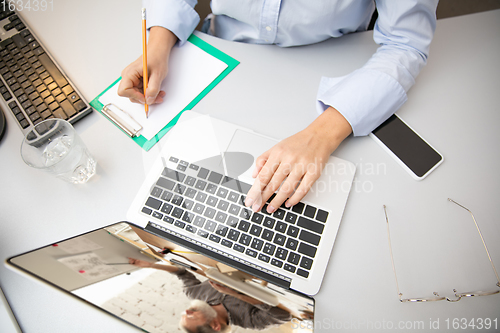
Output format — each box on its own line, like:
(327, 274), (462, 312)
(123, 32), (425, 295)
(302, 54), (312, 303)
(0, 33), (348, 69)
(317, 0), (438, 136)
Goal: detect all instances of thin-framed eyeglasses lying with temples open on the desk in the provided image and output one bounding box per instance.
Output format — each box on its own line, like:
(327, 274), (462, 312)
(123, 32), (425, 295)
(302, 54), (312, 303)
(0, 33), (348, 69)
(384, 198), (500, 302)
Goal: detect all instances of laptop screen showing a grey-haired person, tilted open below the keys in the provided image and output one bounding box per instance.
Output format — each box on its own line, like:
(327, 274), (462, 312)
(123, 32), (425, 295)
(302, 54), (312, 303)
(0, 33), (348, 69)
(8, 223), (314, 332)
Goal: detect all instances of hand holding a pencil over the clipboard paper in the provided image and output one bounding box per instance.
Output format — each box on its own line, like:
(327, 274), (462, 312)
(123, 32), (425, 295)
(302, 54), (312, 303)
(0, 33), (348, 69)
(118, 27), (177, 105)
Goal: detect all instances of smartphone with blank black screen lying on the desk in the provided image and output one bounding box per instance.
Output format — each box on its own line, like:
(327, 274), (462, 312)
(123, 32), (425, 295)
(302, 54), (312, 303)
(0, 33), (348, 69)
(372, 115), (443, 178)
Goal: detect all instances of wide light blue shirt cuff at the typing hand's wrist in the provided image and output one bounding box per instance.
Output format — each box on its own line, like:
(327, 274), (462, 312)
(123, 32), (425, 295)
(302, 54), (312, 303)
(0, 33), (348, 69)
(316, 68), (407, 136)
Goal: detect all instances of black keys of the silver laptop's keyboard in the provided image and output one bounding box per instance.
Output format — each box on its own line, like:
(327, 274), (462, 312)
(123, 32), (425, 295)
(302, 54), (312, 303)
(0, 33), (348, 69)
(142, 157), (328, 278)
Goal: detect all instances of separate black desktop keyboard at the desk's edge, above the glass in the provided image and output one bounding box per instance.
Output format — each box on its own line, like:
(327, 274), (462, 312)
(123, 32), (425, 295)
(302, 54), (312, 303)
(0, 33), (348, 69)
(0, 6), (92, 134)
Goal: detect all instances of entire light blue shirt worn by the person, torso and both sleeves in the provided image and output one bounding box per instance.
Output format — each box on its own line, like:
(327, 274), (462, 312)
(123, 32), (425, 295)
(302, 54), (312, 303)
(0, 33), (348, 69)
(143, 0), (438, 136)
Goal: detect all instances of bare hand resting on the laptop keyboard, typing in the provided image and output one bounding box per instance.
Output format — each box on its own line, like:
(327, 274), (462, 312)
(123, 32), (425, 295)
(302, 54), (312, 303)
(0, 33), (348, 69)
(245, 107), (352, 213)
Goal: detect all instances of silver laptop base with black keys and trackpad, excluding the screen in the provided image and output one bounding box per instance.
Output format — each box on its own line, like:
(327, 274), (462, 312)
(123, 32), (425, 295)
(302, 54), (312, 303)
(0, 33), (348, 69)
(127, 111), (355, 295)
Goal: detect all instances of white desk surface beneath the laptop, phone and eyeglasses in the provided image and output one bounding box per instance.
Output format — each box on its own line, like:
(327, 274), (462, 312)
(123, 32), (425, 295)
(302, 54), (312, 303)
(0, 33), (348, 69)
(0, 0), (500, 332)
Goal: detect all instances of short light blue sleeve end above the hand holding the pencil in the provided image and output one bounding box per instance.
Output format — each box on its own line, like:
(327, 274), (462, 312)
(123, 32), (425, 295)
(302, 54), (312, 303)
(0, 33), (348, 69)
(142, 0), (200, 45)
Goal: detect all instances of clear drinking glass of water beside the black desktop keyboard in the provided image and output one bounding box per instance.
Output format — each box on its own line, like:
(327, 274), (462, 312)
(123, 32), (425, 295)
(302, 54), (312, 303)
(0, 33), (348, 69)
(21, 119), (96, 184)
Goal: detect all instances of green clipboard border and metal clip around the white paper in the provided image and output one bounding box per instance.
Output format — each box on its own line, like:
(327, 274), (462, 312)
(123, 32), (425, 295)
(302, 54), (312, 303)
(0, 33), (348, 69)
(90, 35), (240, 151)
